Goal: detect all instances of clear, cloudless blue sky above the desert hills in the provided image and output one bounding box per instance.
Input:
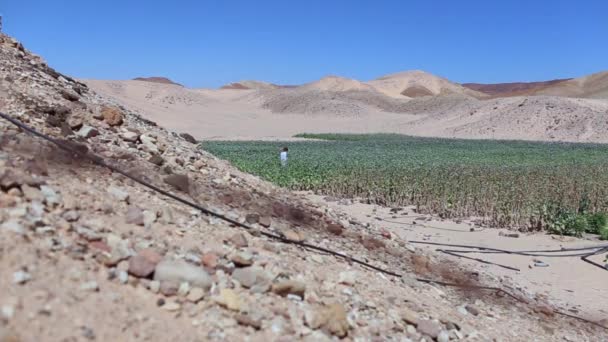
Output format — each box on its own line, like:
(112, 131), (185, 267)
(0, 0), (608, 87)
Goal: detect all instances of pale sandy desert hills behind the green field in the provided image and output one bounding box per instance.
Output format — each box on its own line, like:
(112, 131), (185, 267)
(85, 78), (608, 142)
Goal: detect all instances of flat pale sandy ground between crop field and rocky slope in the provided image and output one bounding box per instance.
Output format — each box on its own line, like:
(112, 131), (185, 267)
(307, 195), (608, 320)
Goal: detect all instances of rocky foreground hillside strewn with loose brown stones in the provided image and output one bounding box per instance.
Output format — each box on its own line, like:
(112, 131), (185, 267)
(0, 35), (608, 342)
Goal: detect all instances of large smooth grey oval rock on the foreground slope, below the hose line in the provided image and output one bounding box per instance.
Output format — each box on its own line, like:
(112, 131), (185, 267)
(154, 260), (213, 290)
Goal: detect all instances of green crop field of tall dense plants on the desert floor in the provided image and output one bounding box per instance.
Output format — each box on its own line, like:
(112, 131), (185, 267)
(202, 134), (608, 237)
